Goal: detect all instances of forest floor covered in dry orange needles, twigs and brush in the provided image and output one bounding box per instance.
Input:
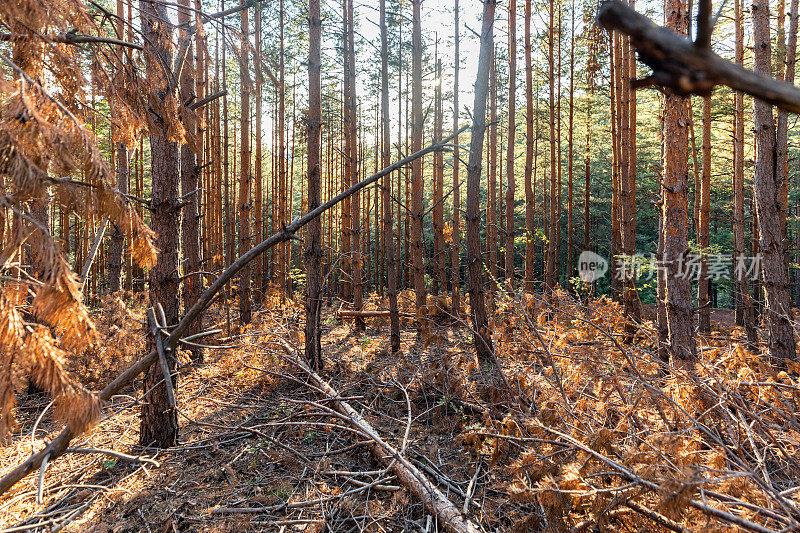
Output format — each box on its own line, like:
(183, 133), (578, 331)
(0, 293), (800, 533)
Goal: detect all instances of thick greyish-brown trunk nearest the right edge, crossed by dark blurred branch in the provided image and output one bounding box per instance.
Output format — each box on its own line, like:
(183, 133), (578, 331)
(752, 0), (796, 366)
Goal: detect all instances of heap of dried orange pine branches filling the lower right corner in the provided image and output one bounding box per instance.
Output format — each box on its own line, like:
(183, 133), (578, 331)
(462, 293), (800, 531)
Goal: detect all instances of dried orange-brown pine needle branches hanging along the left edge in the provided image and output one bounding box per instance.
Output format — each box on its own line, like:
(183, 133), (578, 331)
(0, 0), (159, 438)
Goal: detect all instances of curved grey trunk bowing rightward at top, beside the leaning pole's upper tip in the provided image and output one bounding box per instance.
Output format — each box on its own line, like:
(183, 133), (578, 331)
(466, 0), (497, 366)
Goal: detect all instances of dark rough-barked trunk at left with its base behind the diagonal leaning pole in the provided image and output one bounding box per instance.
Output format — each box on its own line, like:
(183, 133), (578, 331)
(139, 0), (180, 448)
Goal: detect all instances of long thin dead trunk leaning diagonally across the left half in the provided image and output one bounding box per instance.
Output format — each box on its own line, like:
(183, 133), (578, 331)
(0, 126), (468, 495)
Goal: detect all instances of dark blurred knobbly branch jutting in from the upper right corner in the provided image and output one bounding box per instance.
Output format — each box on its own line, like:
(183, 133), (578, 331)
(597, 0), (800, 113)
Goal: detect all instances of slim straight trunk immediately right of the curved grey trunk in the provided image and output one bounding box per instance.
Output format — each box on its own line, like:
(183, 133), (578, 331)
(505, 0), (517, 286)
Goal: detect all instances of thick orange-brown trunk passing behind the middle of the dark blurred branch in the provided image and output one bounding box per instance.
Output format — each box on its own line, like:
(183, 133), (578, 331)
(661, 0), (697, 368)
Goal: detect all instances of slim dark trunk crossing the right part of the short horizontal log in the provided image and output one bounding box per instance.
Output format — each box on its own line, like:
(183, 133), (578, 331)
(380, 0), (396, 353)
